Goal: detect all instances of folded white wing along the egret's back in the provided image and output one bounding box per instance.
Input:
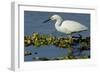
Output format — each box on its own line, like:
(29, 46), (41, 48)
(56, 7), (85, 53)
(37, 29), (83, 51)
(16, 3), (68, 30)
(61, 20), (88, 32)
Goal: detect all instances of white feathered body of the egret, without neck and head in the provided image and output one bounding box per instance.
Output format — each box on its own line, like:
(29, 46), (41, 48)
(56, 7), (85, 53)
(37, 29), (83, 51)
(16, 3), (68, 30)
(59, 20), (87, 34)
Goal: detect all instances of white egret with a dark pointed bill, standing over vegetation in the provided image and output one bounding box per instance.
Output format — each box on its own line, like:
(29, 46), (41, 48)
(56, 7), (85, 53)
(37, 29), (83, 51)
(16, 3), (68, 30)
(44, 15), (88, 35)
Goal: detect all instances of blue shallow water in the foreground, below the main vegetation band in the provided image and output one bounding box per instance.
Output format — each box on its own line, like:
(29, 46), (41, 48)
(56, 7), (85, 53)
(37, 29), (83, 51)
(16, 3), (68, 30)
(24, 45), (90, 61)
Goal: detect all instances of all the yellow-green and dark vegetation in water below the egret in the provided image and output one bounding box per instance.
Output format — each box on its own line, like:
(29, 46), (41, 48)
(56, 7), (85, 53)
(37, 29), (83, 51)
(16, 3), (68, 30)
(24, 32), (90, 60)
